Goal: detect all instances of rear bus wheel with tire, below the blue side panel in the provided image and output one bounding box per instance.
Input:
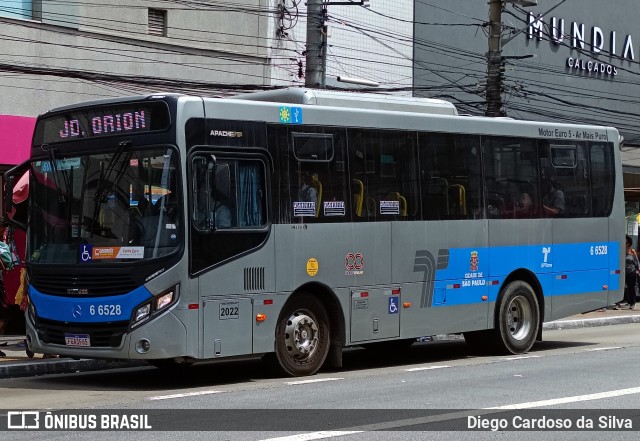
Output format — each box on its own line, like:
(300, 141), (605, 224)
(494, 280), (540, 354)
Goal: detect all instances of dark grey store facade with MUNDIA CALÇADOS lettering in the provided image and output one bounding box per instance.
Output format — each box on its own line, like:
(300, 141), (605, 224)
(413, 0), (640, 236)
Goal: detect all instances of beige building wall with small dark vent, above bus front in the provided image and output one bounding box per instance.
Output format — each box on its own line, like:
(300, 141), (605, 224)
(0, 0), (282, 116)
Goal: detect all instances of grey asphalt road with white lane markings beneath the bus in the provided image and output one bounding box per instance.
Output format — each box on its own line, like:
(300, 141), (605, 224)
(0, 324), (640, 441)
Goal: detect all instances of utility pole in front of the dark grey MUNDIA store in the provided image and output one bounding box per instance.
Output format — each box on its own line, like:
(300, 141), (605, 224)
(485, 0), (505, 116)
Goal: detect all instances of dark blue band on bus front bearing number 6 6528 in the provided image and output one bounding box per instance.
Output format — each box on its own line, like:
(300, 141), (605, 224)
(29, 286), (153, 323)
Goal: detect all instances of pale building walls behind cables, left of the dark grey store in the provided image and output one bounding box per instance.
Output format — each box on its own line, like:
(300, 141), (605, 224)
(0, 0), (413, 117)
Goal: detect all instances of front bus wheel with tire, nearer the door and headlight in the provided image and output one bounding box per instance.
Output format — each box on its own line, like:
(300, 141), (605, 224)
(275, 294), (331, 377)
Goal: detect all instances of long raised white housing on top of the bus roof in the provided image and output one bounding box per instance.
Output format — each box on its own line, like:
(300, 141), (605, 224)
(231, 87), (458, 116)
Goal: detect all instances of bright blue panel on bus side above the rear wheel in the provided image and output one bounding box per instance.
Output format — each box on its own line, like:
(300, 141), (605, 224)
(433, 242), (621, 307)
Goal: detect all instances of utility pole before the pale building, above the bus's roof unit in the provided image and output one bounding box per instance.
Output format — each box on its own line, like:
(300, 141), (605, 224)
(304, 0), (327, 89)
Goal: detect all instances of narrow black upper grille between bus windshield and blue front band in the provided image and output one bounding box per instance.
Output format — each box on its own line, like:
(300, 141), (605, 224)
(31, 273), (139, 296)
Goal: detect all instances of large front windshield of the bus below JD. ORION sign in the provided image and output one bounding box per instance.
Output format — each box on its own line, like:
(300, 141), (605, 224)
(27, 144), (182, 265)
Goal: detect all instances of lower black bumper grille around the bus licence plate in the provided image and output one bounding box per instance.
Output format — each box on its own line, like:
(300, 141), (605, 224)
(36, 319), (129, 348)
